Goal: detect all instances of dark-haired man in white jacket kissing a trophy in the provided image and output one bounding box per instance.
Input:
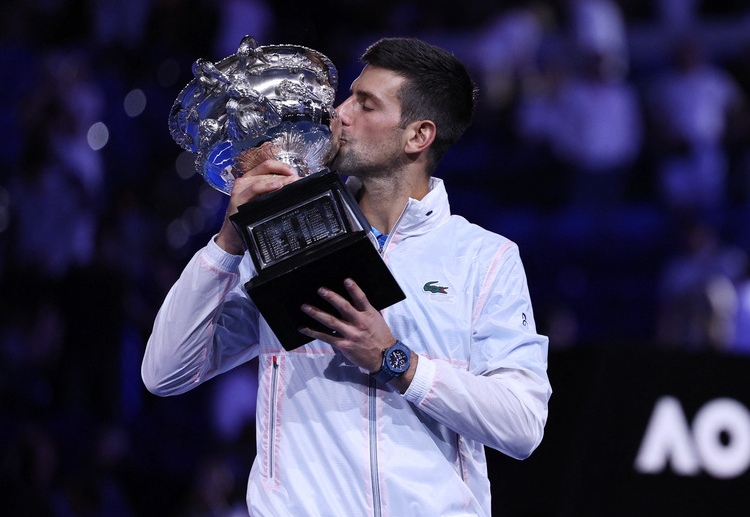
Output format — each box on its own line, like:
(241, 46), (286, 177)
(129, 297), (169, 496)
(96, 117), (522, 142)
(142, 38), (551, 517)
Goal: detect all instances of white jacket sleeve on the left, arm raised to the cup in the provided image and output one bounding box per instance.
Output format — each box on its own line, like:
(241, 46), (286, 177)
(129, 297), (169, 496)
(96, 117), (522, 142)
(141, 239), (259, 396)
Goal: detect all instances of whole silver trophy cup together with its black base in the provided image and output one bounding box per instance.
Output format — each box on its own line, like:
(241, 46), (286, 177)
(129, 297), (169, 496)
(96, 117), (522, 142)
(169, 36), (404, 350)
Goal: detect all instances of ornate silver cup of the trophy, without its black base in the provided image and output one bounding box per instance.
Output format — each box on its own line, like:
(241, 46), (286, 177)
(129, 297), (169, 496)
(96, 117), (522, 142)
(169, 36), (338, 194)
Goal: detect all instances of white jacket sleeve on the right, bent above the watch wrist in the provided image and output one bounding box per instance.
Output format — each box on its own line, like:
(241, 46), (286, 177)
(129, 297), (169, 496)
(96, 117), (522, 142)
(404, 245), (552, 459)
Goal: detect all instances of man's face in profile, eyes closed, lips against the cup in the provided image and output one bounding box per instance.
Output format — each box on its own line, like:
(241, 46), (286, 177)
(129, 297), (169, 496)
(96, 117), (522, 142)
(331, 65), (405, 178)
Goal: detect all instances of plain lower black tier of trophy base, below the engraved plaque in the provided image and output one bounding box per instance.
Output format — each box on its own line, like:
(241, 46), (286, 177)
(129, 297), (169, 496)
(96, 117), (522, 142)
(245, 231), (406, 350)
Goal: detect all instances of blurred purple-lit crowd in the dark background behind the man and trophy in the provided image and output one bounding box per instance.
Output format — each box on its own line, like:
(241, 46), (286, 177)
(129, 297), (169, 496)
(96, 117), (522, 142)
(0, 0), (750, 516)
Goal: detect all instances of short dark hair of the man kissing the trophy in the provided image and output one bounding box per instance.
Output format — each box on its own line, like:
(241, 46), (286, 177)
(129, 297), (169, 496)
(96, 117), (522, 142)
(361, 38), (477, 174)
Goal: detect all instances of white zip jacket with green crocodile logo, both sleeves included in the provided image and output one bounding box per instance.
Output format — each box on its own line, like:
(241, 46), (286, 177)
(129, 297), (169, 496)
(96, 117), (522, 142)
(142, 178), (551, 517)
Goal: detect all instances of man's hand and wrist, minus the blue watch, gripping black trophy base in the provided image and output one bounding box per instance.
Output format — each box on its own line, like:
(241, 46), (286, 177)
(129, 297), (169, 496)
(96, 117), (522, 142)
(300, 278), (419, 393)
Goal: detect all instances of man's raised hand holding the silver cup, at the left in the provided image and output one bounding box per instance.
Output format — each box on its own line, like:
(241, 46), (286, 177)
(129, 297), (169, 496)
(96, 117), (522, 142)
(216, 144), (299, 255)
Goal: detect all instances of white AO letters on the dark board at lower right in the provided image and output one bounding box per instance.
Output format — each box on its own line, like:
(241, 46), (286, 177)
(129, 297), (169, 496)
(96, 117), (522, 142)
(635, 397), (750, 479)
